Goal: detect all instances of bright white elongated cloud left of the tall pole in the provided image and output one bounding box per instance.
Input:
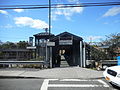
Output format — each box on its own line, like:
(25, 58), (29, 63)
(14, 17), (49, 29)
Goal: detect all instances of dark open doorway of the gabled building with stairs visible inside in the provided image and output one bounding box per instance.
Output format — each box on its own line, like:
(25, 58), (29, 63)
(53, 46), (73, 67)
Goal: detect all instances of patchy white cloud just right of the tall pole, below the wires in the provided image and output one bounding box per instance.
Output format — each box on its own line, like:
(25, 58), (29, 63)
(52, 5), (83, 20)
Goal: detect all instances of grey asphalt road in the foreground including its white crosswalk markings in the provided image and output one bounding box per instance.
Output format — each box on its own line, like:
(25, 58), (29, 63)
(0, 78), (116, 90)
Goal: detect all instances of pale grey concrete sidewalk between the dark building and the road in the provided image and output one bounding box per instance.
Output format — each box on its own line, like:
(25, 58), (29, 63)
(0, 67), (103, 79)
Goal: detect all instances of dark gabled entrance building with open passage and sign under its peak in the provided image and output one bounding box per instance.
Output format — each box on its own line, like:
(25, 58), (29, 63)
(50, 32), (83, 67)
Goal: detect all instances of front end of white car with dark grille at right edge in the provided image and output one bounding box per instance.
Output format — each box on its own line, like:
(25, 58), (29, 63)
(103, 66), (120, 87)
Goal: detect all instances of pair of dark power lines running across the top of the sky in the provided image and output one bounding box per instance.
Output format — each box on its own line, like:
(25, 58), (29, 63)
(0, 2), (120, 10)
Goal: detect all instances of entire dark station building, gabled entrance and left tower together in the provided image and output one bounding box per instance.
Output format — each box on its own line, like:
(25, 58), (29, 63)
(34, 32), (86, 67)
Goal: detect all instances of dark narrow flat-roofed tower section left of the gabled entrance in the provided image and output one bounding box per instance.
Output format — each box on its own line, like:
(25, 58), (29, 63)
(34, 32), (54, 62)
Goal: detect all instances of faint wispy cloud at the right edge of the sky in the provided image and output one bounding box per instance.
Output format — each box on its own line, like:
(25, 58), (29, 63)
(103, 7), (120, 17)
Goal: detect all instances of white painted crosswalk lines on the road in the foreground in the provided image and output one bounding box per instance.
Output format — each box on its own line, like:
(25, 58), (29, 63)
(40, 79), (109, 90)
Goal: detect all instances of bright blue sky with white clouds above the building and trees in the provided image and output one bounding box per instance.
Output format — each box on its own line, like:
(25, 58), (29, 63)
(0, 0), (120, 42)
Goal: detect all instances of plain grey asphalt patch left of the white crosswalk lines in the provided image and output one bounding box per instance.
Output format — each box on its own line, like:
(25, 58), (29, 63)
(0, 79), (43, 90)
